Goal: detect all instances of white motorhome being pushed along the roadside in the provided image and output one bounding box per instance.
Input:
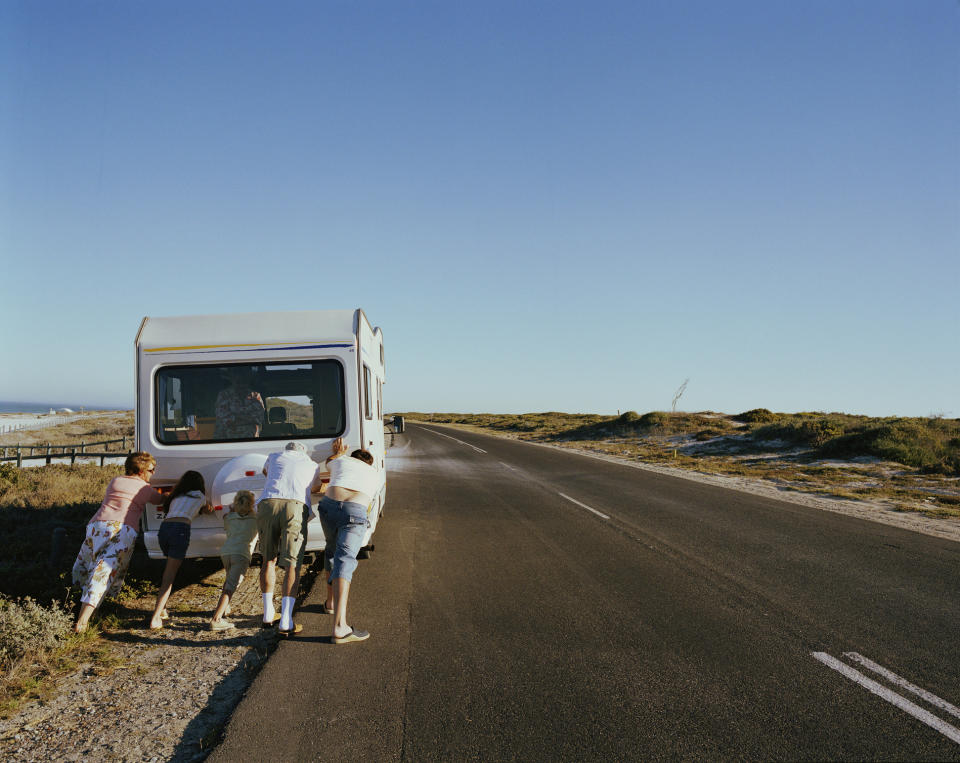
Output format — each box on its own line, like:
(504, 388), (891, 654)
(136, 309), (386, 558)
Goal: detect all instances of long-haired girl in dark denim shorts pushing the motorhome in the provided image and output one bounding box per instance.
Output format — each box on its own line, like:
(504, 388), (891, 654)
(150, 471), (213, 631)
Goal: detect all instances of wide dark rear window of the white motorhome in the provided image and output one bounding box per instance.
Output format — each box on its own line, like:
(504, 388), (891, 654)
(154, 360), (346, 445)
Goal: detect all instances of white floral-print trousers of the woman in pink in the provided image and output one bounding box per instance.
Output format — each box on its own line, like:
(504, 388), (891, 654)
(73, 521), (137, 607)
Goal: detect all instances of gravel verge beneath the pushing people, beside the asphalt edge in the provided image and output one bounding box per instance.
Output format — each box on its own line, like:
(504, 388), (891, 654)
(0, 561), (319, 762)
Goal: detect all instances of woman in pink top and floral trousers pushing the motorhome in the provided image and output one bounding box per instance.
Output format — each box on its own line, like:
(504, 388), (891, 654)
(73, 451), (163, 633)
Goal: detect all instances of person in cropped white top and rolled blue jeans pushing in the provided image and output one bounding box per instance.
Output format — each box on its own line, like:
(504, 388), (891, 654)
(316, 437), (379, 644)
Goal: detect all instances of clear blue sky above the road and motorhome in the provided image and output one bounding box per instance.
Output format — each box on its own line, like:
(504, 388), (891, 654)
(0, 0), (960, 417)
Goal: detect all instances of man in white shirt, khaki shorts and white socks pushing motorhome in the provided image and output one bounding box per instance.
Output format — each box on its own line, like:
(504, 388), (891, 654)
(257, 442), (317, 637)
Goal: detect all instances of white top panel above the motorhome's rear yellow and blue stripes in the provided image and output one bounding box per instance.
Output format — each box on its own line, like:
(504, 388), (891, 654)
(137, 310), (362, 349)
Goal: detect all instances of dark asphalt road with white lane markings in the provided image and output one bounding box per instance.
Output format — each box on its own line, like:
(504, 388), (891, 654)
(211, 425), (960, 761)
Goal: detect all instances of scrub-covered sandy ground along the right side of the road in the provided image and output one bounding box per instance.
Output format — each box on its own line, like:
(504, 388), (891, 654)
(400, 408), (960, 518)
